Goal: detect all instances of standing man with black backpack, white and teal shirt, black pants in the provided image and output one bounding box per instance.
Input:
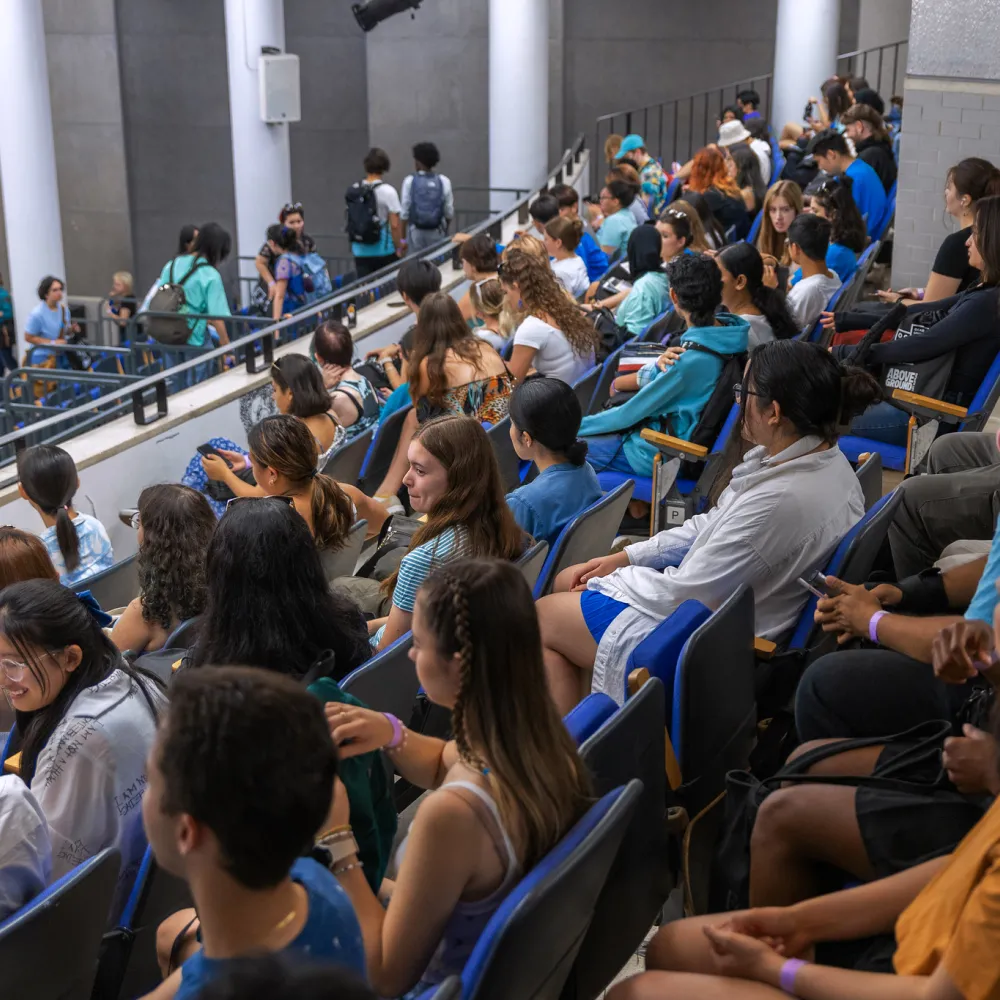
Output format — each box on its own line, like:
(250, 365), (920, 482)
(346, 147), (406, 278)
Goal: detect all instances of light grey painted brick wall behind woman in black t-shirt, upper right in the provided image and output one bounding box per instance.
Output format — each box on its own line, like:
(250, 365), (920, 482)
(892, 77), (1000, 288)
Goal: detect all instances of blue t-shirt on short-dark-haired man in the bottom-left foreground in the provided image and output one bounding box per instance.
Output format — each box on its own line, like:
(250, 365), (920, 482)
(174, 858), (365, 1000)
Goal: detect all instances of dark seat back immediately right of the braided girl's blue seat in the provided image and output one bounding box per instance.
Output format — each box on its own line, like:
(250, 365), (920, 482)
(562, 678), (673, 1000)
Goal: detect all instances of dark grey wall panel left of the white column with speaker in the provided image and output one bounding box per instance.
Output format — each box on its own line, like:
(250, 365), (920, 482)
(116, 0), (236, 293)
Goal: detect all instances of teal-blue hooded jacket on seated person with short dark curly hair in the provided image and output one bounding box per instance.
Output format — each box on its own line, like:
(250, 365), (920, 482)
(580, 313), (750, 476)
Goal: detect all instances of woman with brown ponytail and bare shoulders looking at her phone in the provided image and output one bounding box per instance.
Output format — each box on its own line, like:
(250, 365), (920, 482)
(202, 414), (387, 552)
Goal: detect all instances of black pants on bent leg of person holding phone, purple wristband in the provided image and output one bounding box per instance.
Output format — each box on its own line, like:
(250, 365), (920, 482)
(795, 649), (969, 743)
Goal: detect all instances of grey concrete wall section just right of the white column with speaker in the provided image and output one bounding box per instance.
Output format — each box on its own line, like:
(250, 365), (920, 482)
(286, 0), (372, 256)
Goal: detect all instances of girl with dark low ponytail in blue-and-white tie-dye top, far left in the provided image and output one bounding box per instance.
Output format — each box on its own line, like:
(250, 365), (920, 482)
(17, 444), (115, 587)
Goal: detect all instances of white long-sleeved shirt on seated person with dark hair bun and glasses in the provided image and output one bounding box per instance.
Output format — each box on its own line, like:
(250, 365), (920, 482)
(587, 437), (865, 701)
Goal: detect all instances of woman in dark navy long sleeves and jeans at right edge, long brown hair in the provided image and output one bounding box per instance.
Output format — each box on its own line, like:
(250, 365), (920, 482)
(836, 195), (1000, 445)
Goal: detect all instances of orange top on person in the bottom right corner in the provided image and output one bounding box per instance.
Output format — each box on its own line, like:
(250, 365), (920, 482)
(893, 799), (1000, 1000)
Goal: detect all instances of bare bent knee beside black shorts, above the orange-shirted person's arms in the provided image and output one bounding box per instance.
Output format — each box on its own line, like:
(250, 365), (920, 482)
(750, 785), (875, 906)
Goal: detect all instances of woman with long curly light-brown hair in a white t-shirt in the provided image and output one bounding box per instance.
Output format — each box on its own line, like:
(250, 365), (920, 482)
(500, 248), (598, 385)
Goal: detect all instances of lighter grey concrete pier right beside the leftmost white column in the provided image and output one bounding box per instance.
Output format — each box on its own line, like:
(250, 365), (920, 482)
(42, 0), (133, 295)
